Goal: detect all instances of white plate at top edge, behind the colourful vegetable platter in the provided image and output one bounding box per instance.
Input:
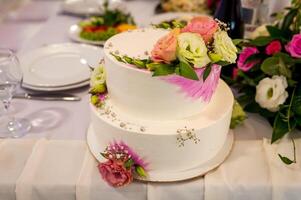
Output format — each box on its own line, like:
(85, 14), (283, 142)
(62, 0), (126, 16)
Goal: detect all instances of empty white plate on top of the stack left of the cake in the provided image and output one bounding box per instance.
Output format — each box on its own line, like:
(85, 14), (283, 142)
(19, 43), (103, 88)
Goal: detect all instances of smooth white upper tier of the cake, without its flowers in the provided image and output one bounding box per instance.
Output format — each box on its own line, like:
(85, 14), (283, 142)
(104, 29), (207, 121)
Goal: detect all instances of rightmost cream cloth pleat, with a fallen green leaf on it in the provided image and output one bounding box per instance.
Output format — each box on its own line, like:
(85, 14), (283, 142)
(263, 137), (301, 200)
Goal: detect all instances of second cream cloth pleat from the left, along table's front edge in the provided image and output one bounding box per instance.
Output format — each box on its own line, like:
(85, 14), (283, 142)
(16, 140), (87, 200)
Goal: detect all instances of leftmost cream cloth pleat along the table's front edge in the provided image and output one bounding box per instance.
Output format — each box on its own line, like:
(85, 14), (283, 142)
(0, 139), (36, 200)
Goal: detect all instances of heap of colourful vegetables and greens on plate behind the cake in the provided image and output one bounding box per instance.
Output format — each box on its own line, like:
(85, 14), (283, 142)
(79, 1), (136, 41)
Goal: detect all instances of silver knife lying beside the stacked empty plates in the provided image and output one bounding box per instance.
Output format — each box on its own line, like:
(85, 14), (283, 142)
(13, 93), (81, 101)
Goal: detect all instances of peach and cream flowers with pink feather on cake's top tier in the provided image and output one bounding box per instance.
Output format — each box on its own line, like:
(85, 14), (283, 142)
(111, 16), (237, 101)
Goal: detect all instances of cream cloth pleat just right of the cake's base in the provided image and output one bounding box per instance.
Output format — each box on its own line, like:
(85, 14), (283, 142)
(205, 140), (271, 200)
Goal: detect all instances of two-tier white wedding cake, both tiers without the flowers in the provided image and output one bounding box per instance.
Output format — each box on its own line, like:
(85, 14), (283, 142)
(87, 17), (234, 186)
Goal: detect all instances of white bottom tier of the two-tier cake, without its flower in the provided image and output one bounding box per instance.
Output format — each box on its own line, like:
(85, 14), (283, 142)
(88, 81), (234, 181)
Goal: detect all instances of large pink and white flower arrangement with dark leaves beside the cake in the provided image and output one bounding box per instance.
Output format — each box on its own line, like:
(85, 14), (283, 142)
(223, 1), (301, 164)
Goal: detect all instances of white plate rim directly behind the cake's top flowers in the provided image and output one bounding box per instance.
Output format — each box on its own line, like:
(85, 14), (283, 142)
(144, 12), (202, 27)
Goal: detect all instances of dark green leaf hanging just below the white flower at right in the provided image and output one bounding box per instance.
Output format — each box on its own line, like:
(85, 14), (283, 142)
(271, 113), (289, 143)
